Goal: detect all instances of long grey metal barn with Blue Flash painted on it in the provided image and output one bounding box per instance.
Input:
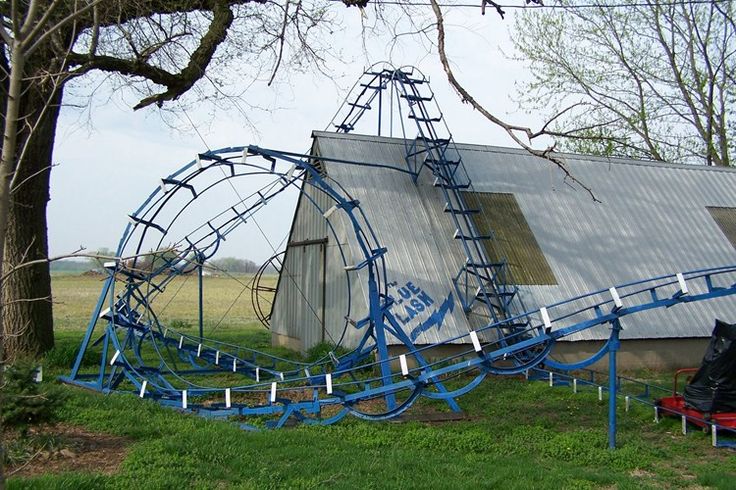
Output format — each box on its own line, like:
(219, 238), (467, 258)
(271, 132), (736, 368)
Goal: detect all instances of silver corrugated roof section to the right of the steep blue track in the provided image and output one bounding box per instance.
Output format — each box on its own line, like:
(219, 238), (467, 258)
(461, 145), (736, 340)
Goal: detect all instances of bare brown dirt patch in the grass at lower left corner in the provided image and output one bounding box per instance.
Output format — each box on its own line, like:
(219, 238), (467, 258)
(6, 424), (131, 478)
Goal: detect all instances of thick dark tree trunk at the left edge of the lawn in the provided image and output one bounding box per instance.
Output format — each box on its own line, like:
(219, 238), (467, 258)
(2, 82), (62, 362)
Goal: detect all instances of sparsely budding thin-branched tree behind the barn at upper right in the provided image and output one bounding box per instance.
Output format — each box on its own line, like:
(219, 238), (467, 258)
(512, 0), (736, 166)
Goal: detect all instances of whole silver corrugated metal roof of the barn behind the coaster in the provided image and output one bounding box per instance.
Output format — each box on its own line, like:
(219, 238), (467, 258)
(314, 132), (736, 344)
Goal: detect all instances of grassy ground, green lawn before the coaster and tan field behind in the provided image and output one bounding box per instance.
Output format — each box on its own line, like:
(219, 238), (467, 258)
(9, 276), (736, 489)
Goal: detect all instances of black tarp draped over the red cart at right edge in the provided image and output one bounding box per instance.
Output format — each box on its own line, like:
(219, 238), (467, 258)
(685, 320), (736, 413)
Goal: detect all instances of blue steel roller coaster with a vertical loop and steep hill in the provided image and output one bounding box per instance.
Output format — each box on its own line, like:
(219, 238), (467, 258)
(63, 65), (736, 447)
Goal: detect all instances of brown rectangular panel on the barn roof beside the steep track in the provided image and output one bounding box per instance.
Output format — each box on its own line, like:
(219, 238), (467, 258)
(465, 192), (557, 285)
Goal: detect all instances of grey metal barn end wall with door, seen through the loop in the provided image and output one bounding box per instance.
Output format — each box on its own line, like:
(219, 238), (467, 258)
(271, 165), (367, 351)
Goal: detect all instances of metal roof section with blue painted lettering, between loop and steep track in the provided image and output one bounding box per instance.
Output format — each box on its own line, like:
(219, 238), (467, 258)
(318, 132), (470, 344)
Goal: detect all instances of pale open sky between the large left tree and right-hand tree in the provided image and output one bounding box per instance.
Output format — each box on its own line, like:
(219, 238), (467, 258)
(48, 5), (540, 262)
